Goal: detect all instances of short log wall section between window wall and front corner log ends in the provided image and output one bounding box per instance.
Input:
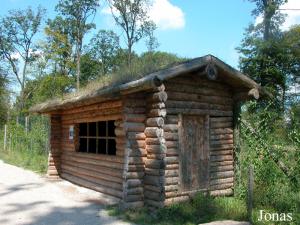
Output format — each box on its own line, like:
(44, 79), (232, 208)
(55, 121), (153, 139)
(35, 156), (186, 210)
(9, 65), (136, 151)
(117, 93), (146, 208)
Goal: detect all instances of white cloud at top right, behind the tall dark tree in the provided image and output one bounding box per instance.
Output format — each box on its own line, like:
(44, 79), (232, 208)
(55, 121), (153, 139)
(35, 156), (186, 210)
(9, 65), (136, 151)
(255, 0), (300, 30)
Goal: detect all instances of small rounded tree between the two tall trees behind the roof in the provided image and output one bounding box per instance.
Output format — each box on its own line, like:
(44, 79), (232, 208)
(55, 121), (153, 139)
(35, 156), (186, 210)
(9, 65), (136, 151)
(88, 30), (120, 75)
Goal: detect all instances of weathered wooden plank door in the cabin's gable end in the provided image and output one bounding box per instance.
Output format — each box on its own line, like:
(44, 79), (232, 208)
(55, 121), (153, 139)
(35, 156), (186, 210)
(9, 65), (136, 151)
(179, 115), (209, 191)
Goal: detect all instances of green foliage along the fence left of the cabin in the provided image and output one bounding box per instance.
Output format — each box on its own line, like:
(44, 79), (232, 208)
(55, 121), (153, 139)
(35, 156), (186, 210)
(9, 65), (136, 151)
(0, 116), (49, 174)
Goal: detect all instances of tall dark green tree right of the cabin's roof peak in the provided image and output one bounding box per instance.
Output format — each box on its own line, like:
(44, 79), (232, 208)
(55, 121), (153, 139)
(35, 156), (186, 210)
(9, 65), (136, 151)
(237, 0), (288, 112)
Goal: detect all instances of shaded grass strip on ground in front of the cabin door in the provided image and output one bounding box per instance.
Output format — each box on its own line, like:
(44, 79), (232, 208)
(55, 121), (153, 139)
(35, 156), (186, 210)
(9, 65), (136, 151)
(108, 193), (247, 225)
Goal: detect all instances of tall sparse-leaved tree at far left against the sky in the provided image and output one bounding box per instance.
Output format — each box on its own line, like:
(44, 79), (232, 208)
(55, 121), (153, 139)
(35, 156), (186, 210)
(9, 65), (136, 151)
(0, 7), (45, 110)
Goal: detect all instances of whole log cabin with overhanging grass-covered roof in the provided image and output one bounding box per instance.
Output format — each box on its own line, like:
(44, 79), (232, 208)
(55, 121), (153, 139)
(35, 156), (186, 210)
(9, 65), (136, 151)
(31, 55), (264, 208)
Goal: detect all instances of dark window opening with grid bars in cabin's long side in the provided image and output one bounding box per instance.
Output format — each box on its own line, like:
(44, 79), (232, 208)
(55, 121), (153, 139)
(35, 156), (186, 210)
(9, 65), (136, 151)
(78, 120), (116, 155)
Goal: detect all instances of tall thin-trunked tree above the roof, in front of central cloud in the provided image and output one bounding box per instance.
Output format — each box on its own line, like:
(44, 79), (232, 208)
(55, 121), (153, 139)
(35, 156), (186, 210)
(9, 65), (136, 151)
(108, 0), (156, 67)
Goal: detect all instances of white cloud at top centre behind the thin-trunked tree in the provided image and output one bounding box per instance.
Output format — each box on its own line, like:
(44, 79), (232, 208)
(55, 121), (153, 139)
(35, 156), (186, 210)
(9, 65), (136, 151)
(101, 0), (185, 30)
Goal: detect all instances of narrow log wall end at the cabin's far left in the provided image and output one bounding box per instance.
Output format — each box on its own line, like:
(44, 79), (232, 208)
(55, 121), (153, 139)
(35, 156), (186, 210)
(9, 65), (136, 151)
(47, 115), (61, 178)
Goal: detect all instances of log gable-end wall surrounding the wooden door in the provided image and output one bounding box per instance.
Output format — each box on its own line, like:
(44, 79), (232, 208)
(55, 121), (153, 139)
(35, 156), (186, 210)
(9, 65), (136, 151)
(162, 74), (233, 205)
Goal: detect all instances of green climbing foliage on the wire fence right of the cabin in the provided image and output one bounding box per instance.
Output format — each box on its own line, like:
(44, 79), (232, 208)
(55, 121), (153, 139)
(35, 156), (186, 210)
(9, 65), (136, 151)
(235, 102), (300, 221)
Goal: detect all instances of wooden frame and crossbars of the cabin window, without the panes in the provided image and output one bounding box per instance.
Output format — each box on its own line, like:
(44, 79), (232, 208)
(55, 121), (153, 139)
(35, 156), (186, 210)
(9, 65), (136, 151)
(76, 120), (117, 156)
